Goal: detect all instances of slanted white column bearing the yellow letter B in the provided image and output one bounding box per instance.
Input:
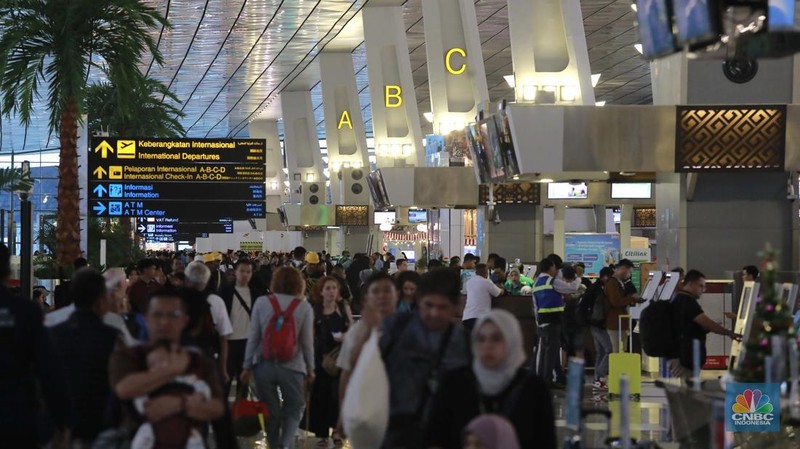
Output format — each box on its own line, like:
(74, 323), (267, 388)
(362, 6), (425, 167)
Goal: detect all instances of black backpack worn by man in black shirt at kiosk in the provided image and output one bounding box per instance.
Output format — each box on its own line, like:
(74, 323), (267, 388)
(639, 300), (680, 358)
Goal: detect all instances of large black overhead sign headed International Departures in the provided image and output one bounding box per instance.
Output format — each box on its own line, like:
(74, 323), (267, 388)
(87, 137), (266, 220)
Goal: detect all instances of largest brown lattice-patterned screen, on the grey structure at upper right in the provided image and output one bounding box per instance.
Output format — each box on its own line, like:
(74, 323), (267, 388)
(675, 105), (786, 172)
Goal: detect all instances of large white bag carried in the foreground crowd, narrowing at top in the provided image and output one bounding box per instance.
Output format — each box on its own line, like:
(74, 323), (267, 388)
(342, 331), (389, 449)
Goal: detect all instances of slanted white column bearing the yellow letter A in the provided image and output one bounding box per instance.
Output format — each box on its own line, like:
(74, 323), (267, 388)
(319, 52), (369, 204)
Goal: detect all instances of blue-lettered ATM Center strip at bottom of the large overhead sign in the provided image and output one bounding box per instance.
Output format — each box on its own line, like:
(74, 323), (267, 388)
(89, 199), (266, 221)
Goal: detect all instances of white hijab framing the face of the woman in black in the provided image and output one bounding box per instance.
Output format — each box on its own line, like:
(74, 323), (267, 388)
(472, 309), (525, 396)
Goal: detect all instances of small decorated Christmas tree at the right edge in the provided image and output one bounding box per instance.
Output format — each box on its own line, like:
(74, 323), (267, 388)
(734, 245), (796, 382)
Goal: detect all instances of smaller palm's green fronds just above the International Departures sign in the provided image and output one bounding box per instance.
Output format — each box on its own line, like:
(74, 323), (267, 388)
(85, 76), (186, 138)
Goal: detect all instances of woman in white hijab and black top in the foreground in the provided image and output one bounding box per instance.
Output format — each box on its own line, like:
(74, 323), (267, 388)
(427, 309), (556, 449)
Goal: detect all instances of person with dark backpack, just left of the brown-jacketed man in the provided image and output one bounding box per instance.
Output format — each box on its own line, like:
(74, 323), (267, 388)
(578, 267), (614, 391)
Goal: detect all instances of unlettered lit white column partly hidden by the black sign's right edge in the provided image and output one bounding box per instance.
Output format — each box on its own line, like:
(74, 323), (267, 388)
(252, 120), (288, 213)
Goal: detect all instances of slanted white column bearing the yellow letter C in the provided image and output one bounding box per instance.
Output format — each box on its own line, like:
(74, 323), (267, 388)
(422, 0), (489, 134)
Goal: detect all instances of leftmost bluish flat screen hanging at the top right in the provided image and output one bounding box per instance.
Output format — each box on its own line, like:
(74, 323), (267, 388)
(636, 0), (677, 59)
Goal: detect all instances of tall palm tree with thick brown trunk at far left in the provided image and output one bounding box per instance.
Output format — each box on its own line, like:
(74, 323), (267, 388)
(0, 0), (167, 265)
